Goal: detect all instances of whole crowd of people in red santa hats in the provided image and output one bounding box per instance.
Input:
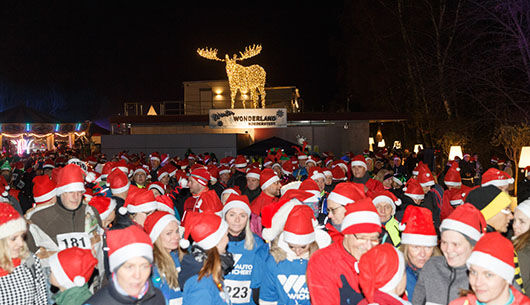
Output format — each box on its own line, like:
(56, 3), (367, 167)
(0, 148), (530, 305)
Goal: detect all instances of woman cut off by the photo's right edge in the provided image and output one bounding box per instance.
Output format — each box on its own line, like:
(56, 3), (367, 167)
(513, 199), (530, 296)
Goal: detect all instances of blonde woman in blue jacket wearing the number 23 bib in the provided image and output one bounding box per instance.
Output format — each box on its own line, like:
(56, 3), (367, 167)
(222, 194), (268, 304)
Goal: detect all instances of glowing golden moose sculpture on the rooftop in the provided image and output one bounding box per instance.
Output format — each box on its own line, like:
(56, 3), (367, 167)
(197, 45), (267, 108)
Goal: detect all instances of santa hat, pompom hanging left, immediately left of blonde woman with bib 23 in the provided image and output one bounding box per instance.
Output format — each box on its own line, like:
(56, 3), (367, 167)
(180, 211), (228, 250)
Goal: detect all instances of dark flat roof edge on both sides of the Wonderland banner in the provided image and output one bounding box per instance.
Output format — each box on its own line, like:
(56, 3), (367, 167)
(110, 112), (408, 125)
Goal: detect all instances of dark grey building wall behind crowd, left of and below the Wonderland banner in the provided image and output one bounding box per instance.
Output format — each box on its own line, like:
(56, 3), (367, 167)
(101, 134), (239, 158)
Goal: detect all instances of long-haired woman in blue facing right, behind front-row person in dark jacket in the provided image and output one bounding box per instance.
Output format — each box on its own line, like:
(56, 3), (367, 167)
(144, 211), (184, 304)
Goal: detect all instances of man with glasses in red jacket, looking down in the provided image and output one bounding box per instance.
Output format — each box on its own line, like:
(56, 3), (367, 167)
(306, 196), (381, 305)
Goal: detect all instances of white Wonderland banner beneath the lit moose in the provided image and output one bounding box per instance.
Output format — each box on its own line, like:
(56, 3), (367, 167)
(208, 108), (287, 128)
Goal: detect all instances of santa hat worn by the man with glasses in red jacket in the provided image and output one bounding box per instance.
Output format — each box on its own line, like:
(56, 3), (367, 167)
(341, 198), (381, 234)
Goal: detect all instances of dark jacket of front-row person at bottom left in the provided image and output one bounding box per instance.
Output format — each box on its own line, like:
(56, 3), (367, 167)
(85, 280), (166, 305)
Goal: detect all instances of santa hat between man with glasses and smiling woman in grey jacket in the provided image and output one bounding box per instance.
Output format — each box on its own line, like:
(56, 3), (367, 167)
(400, 205), (438, 247)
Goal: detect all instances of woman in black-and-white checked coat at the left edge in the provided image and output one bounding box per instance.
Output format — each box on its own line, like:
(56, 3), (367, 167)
(0, 203), (47, 305)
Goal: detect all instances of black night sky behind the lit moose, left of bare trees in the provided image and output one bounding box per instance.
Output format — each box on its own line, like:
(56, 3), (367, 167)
(0, 1), (342, 119)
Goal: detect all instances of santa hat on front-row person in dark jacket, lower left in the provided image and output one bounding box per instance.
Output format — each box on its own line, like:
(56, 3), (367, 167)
(107, 223), (153, 272)
